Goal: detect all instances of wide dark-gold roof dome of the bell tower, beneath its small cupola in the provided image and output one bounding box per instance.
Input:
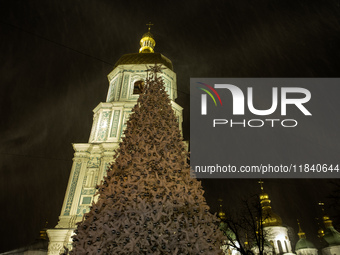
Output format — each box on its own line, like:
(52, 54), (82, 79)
(114, 53), (173, 70)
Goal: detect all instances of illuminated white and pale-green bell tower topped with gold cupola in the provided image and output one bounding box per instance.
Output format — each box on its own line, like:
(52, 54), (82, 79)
(47, 26), (183, 255)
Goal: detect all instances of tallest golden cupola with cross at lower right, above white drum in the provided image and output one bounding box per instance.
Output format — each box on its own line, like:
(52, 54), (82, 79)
(259, 181), (282, 227)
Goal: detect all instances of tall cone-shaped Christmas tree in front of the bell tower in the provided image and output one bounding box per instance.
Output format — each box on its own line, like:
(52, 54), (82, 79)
(70, 65), (223, 255)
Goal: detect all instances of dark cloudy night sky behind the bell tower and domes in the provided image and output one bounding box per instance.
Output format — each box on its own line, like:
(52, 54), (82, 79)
(0, 0), (340, 252)
